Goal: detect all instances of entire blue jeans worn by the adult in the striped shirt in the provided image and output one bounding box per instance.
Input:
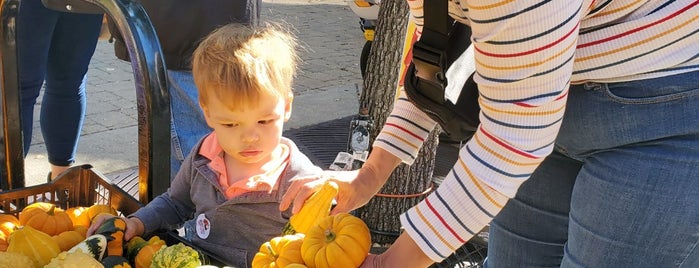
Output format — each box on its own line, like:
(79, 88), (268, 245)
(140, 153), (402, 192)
(485, 71), (699, 268)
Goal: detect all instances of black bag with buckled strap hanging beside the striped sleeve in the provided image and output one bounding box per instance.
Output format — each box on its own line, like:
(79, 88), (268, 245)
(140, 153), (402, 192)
(403, 0), (480, 142)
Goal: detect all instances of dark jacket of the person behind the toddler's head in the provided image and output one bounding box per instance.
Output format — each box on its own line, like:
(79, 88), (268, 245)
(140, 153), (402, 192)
(109, 0), (262, 70)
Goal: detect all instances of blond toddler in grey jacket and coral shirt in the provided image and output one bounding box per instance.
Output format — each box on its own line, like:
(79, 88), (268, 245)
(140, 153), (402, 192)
(88, 24), (322, 267)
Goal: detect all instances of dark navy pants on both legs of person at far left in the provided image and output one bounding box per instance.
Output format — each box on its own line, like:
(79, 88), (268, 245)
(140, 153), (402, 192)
(17, 0), (102, 166)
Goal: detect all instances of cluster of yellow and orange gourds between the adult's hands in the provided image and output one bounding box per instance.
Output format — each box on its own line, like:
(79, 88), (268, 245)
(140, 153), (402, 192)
(252, 181), (371, 268)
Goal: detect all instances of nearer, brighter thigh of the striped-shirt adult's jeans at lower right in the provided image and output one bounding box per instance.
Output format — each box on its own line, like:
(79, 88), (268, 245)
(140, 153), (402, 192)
(563, 139), (699, 267)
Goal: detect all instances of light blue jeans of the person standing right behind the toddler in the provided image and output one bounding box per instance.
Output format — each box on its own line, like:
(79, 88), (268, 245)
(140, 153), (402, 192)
(167, 70), (211, 179)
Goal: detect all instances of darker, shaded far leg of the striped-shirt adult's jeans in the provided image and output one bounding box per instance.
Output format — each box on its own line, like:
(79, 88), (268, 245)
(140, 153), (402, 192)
(485, 152), (582, 267)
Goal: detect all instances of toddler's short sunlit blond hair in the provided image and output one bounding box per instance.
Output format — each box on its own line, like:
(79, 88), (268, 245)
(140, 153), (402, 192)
(192, 24), (298, 110)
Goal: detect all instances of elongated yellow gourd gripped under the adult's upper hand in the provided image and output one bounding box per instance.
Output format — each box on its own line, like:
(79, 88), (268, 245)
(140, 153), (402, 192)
(282, 180), (338, 235)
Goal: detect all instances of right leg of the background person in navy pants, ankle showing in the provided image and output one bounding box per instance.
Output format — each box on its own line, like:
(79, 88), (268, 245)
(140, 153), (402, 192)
(40, 13), (102, 177)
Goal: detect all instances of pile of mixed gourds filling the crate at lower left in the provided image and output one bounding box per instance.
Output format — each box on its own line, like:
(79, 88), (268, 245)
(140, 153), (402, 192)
(0, 202), (201, 268)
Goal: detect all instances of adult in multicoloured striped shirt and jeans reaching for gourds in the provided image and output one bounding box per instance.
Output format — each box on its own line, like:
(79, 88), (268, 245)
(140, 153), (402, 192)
(280, 0), (699, 267)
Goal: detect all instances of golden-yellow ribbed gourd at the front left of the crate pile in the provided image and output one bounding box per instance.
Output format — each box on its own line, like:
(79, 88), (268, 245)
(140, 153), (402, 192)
(7, 226), (61, 267)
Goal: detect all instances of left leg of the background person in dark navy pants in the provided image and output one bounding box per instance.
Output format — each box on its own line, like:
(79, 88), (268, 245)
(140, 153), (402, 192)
(17, 1), (58, 156)
